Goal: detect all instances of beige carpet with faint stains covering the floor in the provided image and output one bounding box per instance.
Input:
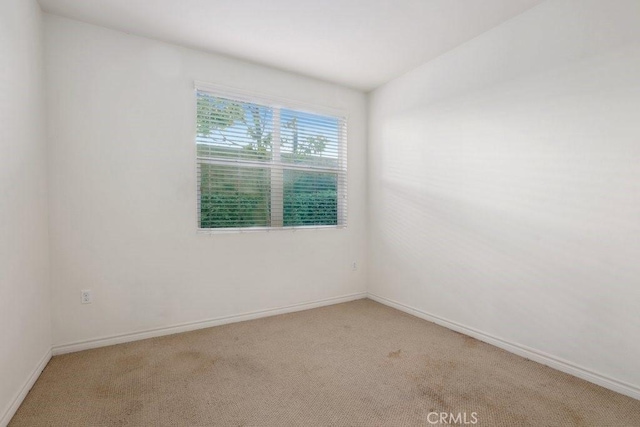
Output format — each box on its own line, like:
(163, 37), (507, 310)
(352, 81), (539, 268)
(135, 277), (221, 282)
(10, 300), (640, 427)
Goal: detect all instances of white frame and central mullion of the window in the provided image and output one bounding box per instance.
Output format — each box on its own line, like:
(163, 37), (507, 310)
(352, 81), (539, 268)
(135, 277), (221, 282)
(192, 80), (349, 234)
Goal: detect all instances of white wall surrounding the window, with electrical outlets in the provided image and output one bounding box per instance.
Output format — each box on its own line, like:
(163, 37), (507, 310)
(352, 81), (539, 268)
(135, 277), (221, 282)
(45, 15), (366, 345)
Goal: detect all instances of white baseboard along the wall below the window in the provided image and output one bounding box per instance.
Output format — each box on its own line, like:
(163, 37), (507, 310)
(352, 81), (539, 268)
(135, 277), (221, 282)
(52, 292), (367, 356)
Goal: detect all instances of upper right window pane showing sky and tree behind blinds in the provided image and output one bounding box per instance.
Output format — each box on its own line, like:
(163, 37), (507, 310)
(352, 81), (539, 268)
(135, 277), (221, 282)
(280, 108), (340, 168)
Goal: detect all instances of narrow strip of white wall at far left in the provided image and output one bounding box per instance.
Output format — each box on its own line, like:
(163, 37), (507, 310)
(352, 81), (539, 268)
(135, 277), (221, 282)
(0, 0), (51, 425)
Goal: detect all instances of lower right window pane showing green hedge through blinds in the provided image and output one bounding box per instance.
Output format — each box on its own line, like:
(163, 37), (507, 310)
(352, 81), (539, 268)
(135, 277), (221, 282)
(283, 169), (338, 227)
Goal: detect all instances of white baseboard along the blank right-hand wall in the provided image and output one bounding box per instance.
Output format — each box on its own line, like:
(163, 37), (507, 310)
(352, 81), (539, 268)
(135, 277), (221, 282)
(368, 293), (640, 400)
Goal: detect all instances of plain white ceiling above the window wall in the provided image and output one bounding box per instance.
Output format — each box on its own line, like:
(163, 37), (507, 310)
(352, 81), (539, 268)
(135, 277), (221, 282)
(39, 0), (542, 91)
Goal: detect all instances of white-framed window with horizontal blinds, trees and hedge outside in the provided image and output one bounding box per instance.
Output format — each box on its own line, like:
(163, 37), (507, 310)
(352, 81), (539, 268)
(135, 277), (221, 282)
(196, 84), (347, 230)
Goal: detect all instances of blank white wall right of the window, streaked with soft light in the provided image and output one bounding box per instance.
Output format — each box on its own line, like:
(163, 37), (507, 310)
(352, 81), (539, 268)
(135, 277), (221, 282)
(369, 0), (640, 392)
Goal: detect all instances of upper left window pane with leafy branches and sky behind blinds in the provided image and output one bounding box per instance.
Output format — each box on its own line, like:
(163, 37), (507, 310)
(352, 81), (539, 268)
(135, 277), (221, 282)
(196, 91), (273, 161)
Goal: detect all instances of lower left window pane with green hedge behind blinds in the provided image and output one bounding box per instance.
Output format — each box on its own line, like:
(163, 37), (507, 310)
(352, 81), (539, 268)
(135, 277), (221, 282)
(199, 163), (271, 228)
